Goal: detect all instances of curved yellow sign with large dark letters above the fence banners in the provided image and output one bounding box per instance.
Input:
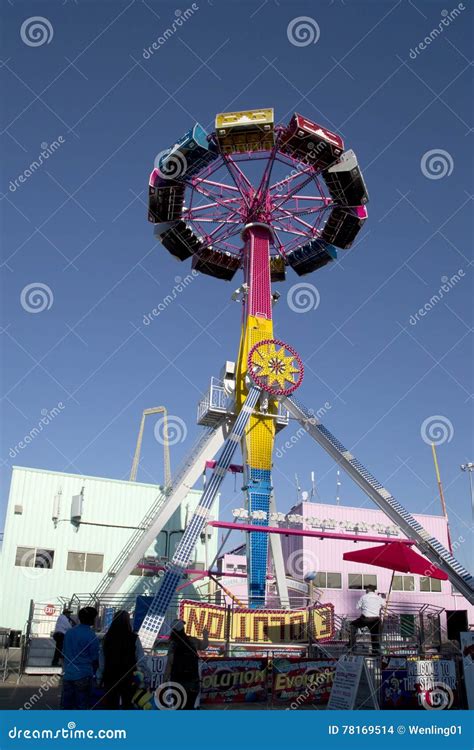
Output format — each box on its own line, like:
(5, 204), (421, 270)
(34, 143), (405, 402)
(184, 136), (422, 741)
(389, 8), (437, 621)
(180, 599), (334, 645)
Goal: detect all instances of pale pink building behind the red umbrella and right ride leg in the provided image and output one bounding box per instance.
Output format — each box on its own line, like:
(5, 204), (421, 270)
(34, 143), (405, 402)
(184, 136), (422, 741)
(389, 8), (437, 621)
(220, 503), (474, 639)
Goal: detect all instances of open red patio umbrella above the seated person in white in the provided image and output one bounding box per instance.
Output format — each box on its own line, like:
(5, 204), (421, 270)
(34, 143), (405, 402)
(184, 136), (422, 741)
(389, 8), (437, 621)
(342, 541), (448, 609)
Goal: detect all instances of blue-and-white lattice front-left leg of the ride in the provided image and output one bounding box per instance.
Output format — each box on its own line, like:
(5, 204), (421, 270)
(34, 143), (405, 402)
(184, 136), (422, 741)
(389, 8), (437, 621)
(139, 386), (261, 649)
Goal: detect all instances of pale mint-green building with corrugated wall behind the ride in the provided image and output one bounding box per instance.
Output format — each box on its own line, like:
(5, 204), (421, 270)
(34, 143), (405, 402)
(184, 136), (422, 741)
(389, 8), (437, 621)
(0, 466), (218, 630)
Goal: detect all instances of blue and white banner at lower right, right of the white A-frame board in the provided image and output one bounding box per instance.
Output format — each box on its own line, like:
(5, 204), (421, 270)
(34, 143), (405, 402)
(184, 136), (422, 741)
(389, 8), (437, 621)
(380, 657), (459, 711)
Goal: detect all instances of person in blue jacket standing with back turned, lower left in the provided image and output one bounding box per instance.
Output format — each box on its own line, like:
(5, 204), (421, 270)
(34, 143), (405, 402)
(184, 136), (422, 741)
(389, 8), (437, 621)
(61, 607), (99, 711)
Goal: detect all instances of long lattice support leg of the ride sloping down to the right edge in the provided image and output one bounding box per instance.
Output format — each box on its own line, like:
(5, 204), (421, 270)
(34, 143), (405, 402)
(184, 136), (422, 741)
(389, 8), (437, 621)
(282, 397), (474, 604)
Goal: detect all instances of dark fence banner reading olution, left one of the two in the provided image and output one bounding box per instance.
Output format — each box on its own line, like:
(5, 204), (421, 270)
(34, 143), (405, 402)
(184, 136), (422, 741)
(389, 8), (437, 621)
(201, 659), (268, 703)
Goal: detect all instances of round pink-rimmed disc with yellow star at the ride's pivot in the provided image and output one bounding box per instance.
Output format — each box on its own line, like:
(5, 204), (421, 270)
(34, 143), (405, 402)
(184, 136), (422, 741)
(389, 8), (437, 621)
(248, 339), (304, 396)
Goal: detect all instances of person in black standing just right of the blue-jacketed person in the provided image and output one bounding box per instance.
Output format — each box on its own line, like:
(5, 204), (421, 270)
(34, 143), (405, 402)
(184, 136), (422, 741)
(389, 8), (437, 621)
(97, 610), (145, 710)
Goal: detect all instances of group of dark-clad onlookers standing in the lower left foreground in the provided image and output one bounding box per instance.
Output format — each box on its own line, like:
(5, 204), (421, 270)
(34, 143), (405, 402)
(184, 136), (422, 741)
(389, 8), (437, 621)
(52, 607), (209, 711)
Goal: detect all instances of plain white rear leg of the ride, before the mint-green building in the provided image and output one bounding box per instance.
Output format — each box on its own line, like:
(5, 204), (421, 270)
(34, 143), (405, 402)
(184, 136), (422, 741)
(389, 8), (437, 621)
(92, 415), (232, 600)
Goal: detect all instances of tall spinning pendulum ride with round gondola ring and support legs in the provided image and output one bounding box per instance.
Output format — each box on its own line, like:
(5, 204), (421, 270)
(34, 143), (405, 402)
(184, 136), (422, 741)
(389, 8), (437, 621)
(90, 109), (474, 649)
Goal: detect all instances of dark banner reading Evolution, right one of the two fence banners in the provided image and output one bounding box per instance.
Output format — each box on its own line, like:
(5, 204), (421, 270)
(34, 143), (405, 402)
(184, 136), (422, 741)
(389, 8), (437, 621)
(272, 658), (337, 708)
